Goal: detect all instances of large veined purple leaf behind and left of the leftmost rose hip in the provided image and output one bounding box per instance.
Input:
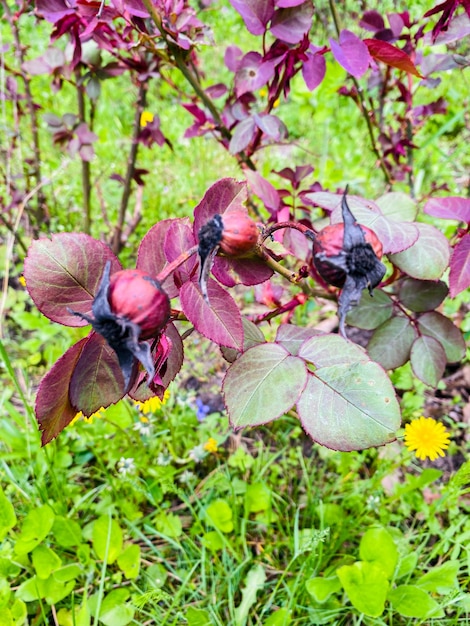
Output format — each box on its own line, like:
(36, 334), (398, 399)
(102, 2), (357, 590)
(24, 233), (122, 326)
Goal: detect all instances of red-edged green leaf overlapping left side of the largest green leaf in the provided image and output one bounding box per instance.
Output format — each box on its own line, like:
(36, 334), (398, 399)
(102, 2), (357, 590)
(223, 343), (307, 429)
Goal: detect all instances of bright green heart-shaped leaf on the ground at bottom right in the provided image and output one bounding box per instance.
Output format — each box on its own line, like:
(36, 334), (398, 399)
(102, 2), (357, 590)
(336, 561), (389, 617)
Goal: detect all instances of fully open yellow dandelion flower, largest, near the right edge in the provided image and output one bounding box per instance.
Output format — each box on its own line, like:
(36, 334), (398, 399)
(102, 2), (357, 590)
(405, 417), (449, 461)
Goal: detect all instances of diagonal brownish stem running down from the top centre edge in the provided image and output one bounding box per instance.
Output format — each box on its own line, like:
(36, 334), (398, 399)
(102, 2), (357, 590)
(142, 0), (256, 171)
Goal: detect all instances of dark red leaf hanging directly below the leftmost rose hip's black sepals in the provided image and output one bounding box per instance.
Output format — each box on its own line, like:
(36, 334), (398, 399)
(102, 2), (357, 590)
(69, 333), (125, 417)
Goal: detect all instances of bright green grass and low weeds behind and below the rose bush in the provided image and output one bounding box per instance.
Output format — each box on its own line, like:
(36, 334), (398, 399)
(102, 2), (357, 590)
(0, 2), (470, 626)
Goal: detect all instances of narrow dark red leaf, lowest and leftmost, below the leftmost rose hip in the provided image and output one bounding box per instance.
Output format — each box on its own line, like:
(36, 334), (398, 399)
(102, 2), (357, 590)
(36, 337), (88, 446)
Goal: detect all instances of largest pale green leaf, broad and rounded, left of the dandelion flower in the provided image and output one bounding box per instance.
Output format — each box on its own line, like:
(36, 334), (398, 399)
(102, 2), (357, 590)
(297, 361), (401, 451)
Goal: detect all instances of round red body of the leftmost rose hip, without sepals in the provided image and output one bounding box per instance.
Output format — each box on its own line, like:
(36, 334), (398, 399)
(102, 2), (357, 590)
(108, 270), (170, 339)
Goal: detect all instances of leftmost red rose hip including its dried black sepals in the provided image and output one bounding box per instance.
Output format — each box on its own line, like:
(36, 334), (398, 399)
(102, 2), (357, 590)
(72, 261), (170, 390)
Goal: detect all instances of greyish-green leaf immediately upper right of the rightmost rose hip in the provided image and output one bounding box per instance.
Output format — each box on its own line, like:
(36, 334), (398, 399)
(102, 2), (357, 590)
(389, 223), (450, 280)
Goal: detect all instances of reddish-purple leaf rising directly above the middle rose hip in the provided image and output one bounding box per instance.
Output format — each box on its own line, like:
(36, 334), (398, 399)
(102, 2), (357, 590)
(193, 178), (248, 238)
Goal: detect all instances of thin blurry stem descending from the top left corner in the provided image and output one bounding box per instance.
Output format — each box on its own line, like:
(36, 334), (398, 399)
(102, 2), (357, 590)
(1, 0), (48, 234)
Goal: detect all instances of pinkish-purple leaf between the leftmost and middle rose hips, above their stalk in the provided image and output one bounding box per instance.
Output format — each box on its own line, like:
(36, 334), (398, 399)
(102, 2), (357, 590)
(137, 217), (196, 298)
